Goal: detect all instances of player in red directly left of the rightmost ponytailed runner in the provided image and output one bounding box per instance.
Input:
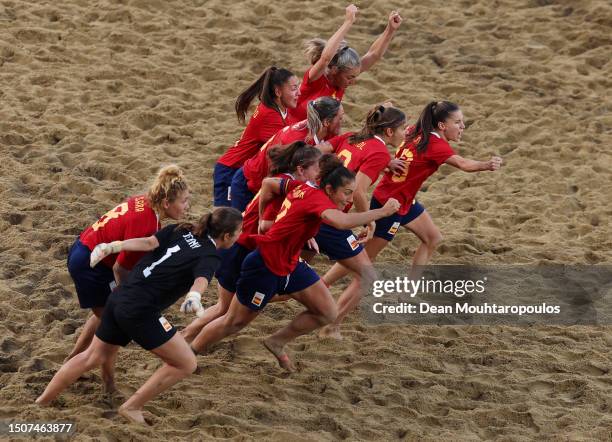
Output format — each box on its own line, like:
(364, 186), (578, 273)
(315, 105), (406, 339)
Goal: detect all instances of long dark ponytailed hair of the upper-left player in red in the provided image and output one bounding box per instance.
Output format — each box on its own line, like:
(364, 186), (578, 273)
(234, 66), (294, 123)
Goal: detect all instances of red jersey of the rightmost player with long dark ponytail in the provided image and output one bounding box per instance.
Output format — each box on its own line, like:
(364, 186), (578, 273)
(373, 128), (455, 215)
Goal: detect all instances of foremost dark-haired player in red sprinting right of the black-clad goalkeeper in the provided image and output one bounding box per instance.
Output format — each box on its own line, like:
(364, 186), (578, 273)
(191, 154), (399, 371)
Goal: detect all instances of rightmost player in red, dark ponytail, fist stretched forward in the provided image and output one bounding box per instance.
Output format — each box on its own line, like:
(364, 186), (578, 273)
(326, 101), (502, 283)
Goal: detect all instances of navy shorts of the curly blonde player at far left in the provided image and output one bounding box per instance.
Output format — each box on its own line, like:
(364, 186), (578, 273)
(68, 238), (116, 308)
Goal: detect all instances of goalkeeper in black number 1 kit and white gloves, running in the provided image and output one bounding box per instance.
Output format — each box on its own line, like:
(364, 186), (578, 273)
(36, 207), (242, 423)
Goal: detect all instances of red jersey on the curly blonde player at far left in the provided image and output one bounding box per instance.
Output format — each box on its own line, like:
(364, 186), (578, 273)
(79, 195), (161, 270)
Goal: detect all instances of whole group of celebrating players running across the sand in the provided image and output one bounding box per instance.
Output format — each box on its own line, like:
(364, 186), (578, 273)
(36, 5), (501, 423)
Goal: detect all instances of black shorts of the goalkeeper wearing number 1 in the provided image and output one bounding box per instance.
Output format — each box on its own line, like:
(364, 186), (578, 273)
(96, 291), (176, 350)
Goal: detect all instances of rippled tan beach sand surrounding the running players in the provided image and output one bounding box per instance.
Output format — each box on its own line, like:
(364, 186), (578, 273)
(0, 0), (612, 440)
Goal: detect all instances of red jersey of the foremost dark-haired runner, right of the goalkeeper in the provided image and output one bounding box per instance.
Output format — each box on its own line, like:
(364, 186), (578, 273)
(256, 182), (338, 276)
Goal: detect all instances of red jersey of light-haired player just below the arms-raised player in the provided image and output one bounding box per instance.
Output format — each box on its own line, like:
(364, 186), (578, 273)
(242, 120), (314, 193)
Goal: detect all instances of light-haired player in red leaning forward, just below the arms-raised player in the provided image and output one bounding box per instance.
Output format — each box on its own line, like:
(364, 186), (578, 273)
(232, 97), (344, 210)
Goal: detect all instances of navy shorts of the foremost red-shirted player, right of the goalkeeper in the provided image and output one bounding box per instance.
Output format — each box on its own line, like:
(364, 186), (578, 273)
(236, 250), (319, 311)
